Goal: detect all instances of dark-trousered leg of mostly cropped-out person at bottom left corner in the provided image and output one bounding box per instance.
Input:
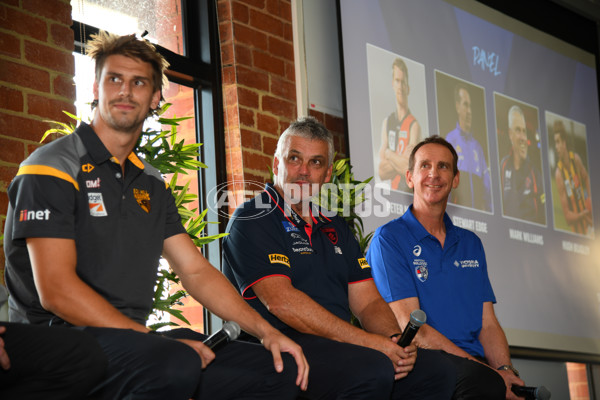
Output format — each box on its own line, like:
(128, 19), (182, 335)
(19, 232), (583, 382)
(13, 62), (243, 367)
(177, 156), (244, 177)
(0, 322), (107, 400)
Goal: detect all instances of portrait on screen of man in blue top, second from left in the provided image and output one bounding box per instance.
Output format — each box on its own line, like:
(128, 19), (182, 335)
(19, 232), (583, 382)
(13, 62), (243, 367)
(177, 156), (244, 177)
(435, 70), (493, 213)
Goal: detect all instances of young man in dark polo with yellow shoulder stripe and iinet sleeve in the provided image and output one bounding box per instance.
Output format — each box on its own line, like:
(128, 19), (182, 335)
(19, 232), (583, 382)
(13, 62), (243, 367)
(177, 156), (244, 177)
(4, 33), (308, 400)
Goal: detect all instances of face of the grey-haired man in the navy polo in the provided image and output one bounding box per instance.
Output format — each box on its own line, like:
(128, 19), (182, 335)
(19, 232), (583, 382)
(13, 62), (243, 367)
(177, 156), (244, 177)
(273, 136), (332, 203)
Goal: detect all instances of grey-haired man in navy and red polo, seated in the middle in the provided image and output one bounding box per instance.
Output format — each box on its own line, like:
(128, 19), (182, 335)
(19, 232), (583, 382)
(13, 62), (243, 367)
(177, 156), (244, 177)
(223, 117), (455, 400)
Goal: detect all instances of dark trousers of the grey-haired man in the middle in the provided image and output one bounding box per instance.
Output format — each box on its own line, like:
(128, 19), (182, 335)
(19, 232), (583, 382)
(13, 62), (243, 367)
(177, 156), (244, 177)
(284, 330), (456, 400)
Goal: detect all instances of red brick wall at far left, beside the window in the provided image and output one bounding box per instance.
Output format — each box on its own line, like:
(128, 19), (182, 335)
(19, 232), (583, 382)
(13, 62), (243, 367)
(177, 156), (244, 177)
(0, 0), (75, 279)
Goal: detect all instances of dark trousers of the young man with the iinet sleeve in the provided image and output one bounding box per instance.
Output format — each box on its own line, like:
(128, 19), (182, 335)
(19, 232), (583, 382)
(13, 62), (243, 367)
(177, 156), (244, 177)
(84, 327), (300, 400)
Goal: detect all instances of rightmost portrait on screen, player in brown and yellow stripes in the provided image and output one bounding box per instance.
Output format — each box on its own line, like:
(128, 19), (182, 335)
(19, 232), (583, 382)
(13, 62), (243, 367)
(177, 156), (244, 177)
(545, 111), (594, 238)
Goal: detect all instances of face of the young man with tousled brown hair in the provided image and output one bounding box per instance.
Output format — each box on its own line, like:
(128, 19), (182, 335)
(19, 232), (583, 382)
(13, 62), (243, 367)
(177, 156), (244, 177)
(94, 55), (160, 133)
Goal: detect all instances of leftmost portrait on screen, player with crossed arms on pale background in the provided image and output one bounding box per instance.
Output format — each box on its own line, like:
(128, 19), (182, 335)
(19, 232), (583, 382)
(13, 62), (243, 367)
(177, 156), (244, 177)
(367, 45), (429, 193)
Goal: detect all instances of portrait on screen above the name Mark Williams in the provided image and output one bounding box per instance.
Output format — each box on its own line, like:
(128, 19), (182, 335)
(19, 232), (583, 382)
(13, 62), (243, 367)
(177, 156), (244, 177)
(494, 93), (546, 226)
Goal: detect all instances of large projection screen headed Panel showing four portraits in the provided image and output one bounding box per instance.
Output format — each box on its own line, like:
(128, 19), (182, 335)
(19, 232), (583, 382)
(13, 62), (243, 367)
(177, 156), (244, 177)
(339, 0), (600, 355)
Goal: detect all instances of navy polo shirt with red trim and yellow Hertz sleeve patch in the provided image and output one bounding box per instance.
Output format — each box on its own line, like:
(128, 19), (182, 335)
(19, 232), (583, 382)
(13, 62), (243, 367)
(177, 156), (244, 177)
(223, 185), (372, 329)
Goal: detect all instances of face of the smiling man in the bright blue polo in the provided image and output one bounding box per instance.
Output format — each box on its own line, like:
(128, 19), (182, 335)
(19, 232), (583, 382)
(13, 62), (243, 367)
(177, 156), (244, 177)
(406, 143), (459, 205)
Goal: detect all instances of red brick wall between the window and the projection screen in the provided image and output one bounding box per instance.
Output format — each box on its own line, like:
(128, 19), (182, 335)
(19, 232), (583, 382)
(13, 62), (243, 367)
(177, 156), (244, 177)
(218, 0), (347, 216)
